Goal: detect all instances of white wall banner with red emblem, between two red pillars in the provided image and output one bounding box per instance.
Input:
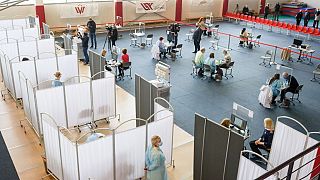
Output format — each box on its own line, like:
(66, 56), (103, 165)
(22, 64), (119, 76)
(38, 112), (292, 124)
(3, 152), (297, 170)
(136, 0), (166, 13)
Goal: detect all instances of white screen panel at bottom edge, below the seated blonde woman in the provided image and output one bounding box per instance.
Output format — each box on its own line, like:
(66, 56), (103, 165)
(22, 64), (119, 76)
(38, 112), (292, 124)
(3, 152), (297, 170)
(237, 156), (277, 180)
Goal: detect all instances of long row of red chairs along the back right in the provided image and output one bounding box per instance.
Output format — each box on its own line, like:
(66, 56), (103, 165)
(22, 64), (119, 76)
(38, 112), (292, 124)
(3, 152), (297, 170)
(225, 12), (320, 36)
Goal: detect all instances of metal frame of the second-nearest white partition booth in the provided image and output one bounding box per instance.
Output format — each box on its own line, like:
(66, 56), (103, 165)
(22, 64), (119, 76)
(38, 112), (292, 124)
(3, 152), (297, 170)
(19, 71), (116, 137)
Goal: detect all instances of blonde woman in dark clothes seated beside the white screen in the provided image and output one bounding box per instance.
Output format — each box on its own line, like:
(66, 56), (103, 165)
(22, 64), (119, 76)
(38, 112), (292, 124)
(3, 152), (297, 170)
(249, 118), (274, 160)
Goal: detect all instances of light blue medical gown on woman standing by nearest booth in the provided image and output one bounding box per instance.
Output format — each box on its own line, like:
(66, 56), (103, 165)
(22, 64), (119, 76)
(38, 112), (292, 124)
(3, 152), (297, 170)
(146, 145), (168, 180)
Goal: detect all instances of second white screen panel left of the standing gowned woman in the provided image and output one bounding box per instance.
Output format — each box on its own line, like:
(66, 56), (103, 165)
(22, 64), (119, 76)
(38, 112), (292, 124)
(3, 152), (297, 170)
(78, 136), (113, 180)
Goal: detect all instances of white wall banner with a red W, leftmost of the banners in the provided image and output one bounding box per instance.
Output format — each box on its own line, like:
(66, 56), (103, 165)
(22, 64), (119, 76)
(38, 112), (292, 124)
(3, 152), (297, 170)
(60, 3), (99, 18)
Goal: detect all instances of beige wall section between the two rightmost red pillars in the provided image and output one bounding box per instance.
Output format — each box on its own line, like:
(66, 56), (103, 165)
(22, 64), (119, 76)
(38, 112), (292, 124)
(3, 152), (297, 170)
(182, 0), (223, 20)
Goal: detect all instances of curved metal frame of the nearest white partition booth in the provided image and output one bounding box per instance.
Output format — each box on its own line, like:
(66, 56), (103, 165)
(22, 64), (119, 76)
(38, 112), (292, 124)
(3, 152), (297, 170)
(40, 98), (174, 180)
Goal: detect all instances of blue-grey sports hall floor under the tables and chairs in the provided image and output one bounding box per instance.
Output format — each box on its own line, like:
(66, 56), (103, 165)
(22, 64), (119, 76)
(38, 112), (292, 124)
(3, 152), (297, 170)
(89, 21), (320, 139)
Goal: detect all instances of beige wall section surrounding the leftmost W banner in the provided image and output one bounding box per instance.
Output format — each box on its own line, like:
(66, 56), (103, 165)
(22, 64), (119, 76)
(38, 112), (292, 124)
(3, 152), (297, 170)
(44, 2), (114, 27)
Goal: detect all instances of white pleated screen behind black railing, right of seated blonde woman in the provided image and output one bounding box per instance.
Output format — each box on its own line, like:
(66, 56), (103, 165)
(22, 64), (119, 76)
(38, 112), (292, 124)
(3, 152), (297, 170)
(268, 121), (307, 179)
